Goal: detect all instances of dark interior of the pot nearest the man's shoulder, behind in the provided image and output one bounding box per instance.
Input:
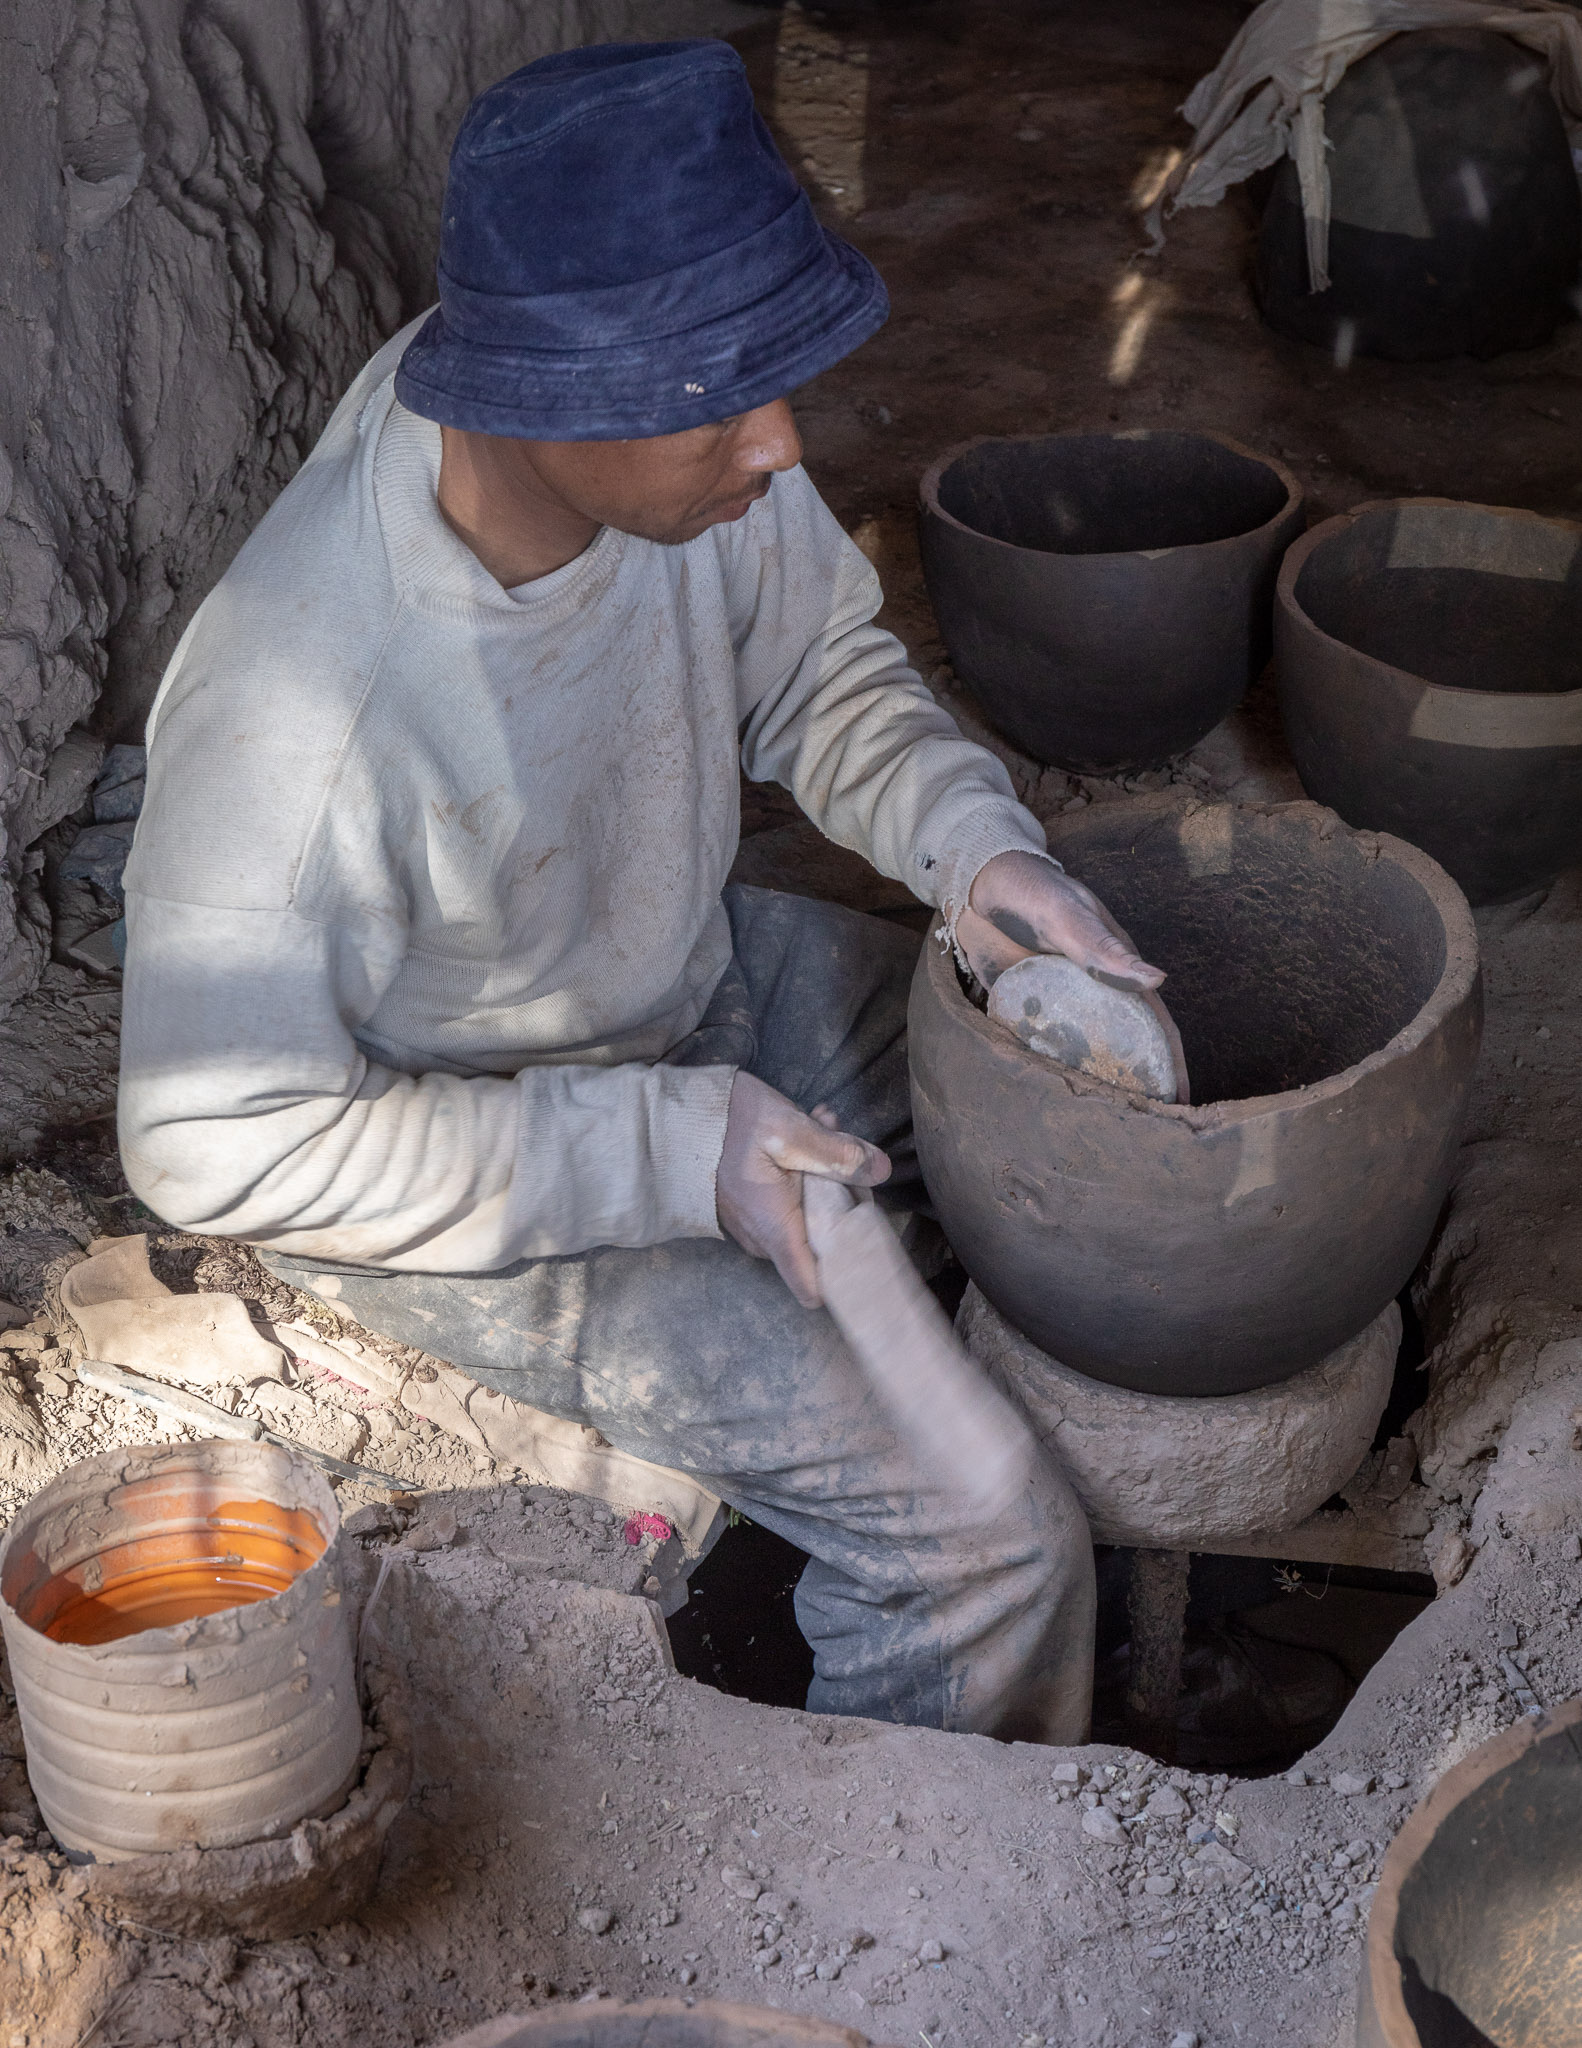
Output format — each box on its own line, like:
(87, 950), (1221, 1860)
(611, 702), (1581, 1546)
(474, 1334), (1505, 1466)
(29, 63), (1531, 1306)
(939, 434), (1287, 555)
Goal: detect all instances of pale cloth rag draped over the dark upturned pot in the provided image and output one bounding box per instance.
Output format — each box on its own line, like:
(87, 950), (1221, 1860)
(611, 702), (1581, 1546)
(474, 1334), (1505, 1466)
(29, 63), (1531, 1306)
(1146, 0), (1582, 291)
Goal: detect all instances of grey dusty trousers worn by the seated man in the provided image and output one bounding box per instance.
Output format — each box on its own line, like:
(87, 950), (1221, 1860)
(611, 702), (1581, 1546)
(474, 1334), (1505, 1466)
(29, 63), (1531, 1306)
(266, 887), (1094, 1743)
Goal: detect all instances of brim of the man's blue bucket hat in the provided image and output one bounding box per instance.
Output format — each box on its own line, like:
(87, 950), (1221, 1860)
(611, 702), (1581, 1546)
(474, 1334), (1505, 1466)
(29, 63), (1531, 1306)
(396, 229), (889, 440)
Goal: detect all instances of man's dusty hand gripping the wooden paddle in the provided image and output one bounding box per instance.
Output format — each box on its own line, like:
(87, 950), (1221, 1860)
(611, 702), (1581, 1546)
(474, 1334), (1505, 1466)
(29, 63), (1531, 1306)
(715, 1069), (889, 1309)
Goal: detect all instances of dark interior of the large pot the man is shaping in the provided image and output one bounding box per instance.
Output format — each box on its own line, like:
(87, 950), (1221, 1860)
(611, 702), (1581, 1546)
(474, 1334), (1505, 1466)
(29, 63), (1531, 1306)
(1029, 823), (1445, 1108)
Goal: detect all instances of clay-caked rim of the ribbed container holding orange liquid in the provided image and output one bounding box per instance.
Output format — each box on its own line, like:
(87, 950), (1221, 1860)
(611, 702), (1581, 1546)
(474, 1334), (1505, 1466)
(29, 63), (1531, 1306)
(0, 1436), (340, 1683)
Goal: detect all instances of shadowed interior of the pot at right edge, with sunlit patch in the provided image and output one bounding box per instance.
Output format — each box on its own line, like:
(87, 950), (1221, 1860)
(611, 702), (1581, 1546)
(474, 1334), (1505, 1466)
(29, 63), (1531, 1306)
(1295, 506), (1582, 692)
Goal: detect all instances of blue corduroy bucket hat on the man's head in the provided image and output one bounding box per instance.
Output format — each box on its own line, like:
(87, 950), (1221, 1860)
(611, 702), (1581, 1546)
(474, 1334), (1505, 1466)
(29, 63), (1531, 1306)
(396, 41), (889, 440)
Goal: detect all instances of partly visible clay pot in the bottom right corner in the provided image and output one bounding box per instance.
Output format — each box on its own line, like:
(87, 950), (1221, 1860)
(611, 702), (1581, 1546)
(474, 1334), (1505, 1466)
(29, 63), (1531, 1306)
(1357, 1700), (1582, 2048)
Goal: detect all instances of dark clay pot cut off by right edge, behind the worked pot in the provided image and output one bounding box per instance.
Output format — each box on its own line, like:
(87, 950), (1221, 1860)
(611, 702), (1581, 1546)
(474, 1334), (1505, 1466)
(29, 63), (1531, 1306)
(1275, 498), (1582, 903)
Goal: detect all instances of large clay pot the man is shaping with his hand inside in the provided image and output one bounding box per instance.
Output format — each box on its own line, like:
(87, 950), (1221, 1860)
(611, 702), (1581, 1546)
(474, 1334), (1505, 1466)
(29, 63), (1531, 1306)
(910, 797), (1482, 1395)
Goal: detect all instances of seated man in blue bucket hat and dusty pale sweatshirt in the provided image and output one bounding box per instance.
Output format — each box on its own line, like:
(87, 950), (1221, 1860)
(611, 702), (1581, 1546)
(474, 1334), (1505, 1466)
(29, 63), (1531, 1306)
(121, 43), (1160, 1739)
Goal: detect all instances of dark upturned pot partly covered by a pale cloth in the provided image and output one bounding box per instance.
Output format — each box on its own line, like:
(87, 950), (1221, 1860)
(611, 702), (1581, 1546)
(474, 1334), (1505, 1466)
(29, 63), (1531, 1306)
(1258, 29), (1582, 362)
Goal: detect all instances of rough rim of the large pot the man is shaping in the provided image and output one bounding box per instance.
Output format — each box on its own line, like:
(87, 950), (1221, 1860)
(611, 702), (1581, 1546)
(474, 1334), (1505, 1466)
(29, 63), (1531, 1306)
(924, 791), (1480, 1135)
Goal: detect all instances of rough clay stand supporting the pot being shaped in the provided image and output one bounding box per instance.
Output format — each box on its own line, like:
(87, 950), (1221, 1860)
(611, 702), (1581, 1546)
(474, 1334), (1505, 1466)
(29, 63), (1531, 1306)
(957, 1286), (1402, 1550)
